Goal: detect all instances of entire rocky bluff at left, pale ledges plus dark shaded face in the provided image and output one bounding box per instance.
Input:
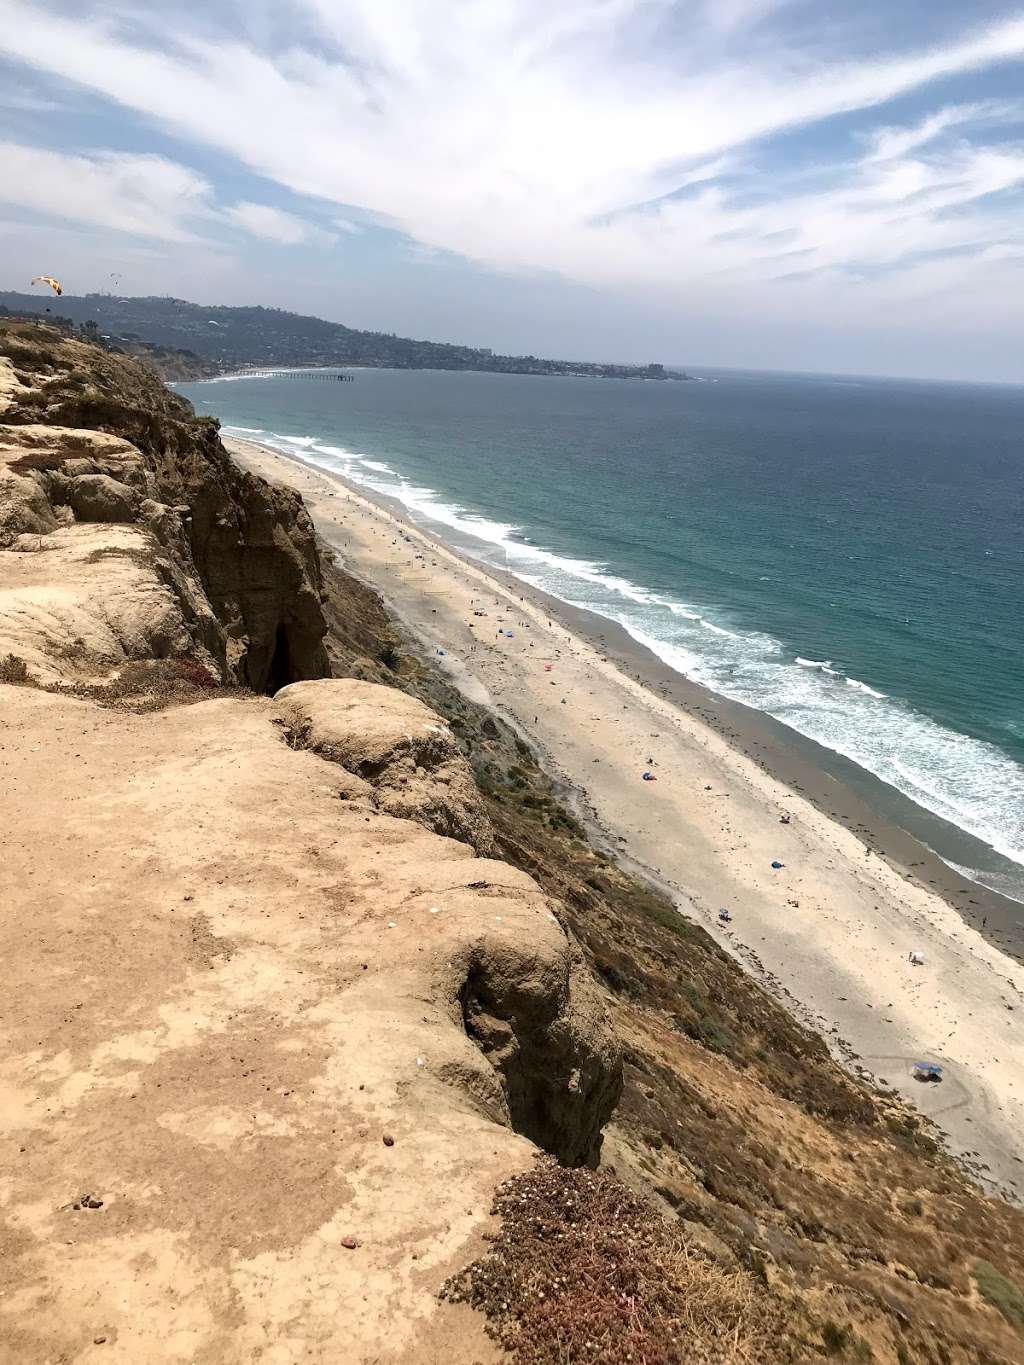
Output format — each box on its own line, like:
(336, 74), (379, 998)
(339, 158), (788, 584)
(0, 324), (329, 692)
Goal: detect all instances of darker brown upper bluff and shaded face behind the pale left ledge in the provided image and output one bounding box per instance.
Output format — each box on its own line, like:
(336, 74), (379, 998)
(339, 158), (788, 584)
(0, 322), (329, 692)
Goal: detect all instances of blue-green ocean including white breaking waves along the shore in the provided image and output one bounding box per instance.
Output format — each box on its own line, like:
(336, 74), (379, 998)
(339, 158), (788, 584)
(176, 370), (1024, 901)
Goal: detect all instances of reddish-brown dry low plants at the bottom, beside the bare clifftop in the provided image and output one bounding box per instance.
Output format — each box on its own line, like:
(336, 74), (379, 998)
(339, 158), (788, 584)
(442, 1158), (793, 1365)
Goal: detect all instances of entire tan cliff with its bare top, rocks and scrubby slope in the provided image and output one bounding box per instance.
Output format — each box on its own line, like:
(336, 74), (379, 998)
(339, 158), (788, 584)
(0, 324), (1024, 1365)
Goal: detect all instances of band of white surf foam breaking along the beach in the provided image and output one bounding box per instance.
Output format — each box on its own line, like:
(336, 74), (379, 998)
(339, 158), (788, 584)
(255, 420), (1024, 865)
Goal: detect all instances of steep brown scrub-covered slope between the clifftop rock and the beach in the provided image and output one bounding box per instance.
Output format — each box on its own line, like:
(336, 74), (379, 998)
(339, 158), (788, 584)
(316, 553), (1024, 1365)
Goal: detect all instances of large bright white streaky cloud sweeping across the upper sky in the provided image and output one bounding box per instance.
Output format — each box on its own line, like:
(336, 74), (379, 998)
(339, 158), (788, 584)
(0, 0), (1024, 330)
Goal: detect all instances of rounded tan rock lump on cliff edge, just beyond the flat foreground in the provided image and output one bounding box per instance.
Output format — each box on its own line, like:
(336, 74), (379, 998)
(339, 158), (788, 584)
(274, 678), (494, 854)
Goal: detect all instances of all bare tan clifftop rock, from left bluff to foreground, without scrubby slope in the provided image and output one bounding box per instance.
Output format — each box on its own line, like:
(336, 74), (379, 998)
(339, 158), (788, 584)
(0, 322), (623, 1365)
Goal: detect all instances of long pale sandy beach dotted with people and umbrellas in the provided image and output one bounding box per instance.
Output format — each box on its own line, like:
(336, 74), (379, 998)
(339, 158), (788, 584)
(225, 438), (1024, 1200)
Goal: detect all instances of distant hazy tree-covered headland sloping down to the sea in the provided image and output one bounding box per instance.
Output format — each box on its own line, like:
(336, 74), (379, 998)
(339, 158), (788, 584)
(0, 292), (688, 379)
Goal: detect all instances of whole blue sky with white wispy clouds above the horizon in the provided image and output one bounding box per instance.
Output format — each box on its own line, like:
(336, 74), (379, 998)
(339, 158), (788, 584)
(0, 0), (1024, 382)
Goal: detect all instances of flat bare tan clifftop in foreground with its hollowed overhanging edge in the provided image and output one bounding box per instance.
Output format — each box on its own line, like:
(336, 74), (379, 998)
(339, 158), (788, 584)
(0, 684), (621, 1365)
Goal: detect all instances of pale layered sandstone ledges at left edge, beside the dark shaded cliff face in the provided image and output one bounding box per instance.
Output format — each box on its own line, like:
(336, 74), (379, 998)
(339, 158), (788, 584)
(0, 425), (223, 684)
